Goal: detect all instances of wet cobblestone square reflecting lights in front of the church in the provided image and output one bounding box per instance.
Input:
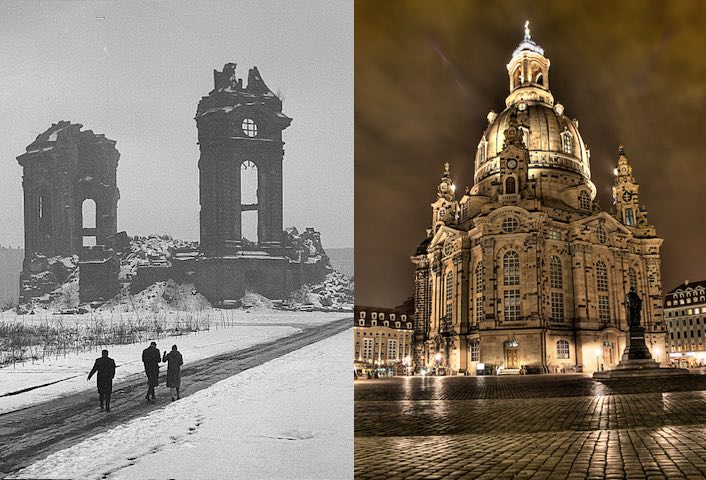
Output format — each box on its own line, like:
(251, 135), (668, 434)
(355, 375), (706, 479)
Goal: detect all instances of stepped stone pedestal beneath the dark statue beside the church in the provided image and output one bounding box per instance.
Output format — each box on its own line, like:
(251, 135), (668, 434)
(593, 326), (689, 380)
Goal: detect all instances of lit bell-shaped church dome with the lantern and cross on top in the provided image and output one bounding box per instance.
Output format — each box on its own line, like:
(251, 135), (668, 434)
(474, 23), (595, 196)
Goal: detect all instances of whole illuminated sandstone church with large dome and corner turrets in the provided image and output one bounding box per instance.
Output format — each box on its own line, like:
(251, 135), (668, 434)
(412, 25), (667, 375)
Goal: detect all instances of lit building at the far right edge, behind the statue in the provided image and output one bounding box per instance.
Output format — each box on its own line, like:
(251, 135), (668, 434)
(664, 280), (706, 367)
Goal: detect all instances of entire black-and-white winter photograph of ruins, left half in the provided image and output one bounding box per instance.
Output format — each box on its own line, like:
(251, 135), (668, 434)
(0, 0), (354, 479)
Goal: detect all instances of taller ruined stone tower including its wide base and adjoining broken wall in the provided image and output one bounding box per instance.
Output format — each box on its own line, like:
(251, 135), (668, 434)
(194, 63), (330, 303)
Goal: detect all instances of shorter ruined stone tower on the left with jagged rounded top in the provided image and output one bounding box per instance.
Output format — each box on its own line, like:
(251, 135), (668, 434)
(17, 121), (120, 302)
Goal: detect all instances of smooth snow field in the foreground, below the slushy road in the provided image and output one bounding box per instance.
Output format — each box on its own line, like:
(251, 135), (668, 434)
(12, 329), (353, 479)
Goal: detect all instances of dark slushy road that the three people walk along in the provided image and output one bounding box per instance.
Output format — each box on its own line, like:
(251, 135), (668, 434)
(0, 318), (351, 476)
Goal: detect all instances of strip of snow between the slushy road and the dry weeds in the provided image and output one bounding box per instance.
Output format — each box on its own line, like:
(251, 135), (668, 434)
(0, 309), (339, 414)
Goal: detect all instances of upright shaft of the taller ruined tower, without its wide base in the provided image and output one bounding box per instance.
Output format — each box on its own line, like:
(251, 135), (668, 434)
(195, 63), (292, 255)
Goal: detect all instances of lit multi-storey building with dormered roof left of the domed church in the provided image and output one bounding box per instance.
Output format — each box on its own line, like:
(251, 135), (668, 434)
(353, 306), (414, 375)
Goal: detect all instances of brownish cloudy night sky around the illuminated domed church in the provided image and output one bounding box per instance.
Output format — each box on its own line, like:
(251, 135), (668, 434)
(355, 0), (706, 306)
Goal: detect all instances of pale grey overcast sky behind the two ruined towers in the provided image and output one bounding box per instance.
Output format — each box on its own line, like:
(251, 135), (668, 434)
(0, 0), (353, 248)
